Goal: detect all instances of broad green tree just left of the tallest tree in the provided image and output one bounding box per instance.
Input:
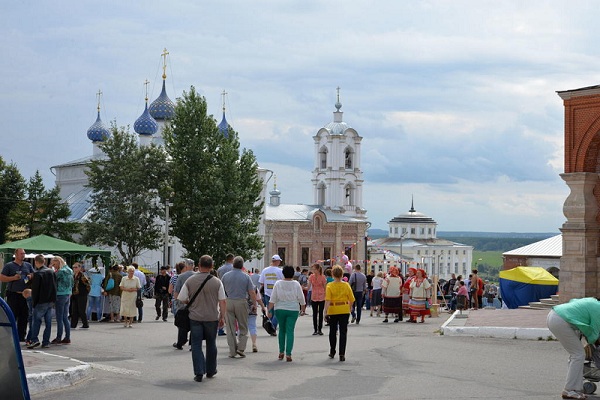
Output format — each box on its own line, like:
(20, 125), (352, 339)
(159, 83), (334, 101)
(83, 124), (168, 264)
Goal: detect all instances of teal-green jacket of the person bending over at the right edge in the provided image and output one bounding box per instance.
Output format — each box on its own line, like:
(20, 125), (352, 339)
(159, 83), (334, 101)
(554, 297), (600, 343)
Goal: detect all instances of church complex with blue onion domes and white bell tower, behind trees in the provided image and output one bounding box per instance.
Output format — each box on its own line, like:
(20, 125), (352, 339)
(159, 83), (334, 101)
(51, 49), (369, 271)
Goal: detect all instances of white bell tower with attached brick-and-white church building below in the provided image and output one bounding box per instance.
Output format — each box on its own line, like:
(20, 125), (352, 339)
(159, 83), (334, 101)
(263, 88), (370, 267)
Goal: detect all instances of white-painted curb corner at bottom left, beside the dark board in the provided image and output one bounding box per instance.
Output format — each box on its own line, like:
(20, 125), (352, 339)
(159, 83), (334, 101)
(27, 352), (92, 394)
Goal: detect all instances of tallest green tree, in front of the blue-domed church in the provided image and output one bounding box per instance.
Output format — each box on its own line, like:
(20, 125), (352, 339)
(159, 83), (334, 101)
(163, 87), (263, 262)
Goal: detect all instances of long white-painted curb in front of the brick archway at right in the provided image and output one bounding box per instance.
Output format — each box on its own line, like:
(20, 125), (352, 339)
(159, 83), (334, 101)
(441, 313), (556, 340)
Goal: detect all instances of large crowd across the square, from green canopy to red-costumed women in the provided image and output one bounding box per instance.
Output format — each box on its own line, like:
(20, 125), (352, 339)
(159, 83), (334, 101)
(0, 245), (454, 381)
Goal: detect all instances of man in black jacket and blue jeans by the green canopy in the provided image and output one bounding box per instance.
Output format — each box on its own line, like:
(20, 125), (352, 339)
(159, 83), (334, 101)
(27, 254), (56, 349)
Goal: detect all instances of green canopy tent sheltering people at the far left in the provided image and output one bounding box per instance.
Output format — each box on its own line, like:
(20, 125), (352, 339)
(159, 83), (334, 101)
(0, 235), (110, 292)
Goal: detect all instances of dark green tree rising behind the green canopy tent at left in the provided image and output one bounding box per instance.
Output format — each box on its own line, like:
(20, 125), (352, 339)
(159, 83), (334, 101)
(11, 171), (79, 240)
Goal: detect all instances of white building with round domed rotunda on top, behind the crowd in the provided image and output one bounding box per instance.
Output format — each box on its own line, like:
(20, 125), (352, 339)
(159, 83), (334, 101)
(369, 204), (473, 278)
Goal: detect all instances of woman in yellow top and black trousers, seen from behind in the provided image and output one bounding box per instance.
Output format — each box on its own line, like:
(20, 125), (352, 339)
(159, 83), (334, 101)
(325, 265), (354, 361)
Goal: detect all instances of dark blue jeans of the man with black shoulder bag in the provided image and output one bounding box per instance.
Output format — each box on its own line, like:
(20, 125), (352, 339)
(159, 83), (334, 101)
(190, 319), (219, 375)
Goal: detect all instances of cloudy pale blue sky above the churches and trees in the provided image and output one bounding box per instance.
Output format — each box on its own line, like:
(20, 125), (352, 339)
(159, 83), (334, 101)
(0, 0), (600, 233)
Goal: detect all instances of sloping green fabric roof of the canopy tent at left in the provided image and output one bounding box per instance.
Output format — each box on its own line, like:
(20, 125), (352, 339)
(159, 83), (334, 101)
(0, 235), (110, 257)
